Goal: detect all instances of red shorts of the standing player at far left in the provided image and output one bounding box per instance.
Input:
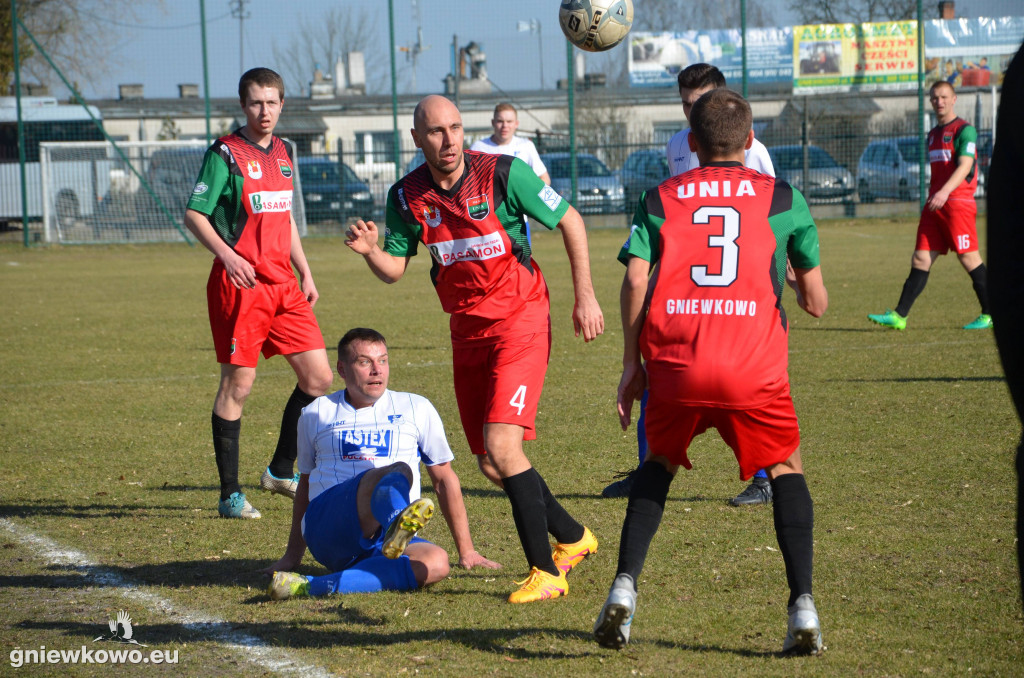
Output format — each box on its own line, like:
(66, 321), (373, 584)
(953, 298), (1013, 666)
(206, 264), (325, 368)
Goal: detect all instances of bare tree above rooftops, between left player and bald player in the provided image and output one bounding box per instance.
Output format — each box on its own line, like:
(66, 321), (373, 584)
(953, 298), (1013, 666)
(273, 4), (386, 94)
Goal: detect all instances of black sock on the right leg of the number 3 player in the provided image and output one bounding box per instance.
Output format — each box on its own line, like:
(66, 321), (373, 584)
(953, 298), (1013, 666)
(771, 473), (814, 605)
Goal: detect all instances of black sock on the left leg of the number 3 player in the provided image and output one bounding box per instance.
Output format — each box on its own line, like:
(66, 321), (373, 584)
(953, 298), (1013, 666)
(615, 461), (673, 582)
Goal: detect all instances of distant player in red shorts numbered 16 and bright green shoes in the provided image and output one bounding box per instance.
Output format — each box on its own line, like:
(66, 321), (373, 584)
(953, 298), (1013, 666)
(867, 81), (992, 330)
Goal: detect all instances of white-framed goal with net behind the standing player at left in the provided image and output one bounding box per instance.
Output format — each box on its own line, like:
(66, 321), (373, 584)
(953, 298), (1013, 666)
(38, 139), (306, 244)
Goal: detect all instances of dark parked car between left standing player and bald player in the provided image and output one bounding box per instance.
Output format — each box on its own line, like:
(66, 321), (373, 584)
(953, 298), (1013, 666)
(298, 156), (374, 223)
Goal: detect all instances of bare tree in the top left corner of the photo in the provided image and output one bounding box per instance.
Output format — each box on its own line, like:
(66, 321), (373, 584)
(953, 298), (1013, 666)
(0, 0), (163, 93)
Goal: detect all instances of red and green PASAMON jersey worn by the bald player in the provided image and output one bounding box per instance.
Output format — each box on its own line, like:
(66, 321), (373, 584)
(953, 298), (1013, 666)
(384, 151), (568, 343)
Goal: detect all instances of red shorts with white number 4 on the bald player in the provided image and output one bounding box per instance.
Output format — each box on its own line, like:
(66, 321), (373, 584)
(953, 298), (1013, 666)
(452, 325), (551, 455)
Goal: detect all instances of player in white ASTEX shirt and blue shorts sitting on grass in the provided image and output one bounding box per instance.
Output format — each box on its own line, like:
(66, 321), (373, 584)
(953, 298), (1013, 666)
(264, 328), (501, 600)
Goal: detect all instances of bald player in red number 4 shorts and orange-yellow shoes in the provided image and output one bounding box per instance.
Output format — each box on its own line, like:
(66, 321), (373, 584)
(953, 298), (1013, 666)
(346, 95), (604, 602)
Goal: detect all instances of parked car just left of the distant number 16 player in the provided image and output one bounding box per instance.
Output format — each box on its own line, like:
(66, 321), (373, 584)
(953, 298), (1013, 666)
(857, 136), (931, 203)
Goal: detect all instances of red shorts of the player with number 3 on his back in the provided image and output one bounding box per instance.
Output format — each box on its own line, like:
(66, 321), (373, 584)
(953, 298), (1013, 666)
(645, 386), (800, 480)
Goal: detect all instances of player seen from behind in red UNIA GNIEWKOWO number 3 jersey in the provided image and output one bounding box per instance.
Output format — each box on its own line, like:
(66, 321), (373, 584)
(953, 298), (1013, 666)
(594, 89), (828, 653)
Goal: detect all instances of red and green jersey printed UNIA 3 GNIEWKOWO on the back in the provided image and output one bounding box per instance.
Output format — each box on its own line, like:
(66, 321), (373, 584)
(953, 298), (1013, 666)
(618, 163), (818, 409)
